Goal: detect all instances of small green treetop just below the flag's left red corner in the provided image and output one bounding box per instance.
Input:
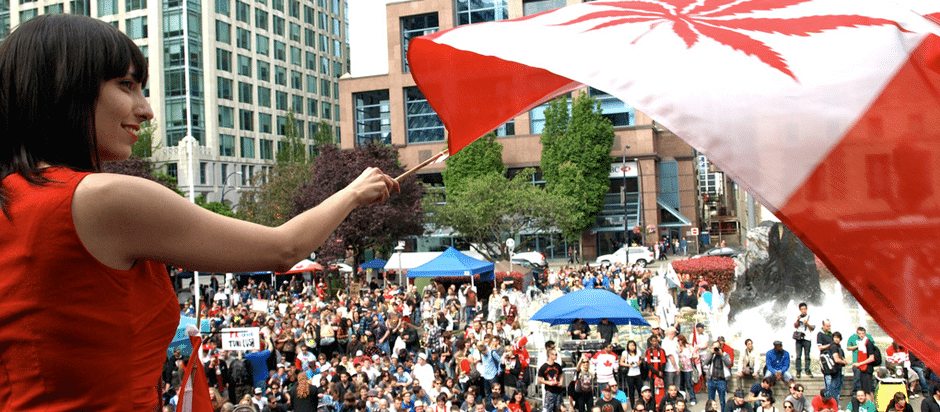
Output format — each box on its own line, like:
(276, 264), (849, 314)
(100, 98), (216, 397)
(441, 133), (506, 196)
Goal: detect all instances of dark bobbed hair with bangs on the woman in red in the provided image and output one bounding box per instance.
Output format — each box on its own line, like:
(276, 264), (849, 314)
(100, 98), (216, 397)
(0, 14), (147, 213)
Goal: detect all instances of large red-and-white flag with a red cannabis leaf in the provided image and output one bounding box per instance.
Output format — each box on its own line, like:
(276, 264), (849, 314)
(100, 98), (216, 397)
(408, 0), (940, 370)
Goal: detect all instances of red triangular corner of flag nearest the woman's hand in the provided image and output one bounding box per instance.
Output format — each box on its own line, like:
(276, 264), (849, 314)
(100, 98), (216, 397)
(408, 36), (580, 155)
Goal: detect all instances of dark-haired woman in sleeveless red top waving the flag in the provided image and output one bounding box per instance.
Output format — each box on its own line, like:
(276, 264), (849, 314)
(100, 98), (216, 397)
(0, 14), (399, 411)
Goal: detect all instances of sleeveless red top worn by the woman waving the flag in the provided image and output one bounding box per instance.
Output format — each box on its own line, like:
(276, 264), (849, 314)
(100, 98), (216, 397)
(0, 168), (179, 411)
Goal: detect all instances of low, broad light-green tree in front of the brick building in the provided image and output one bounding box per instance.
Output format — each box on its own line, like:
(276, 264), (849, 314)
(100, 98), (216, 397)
(424, 170), (564, 261)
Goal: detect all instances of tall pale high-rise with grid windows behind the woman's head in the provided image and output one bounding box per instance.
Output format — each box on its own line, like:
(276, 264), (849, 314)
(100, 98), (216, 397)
(0, 0), (349, 208)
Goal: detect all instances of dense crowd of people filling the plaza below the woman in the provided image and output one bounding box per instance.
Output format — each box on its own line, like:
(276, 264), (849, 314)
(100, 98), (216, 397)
(164, 258), (940, 412)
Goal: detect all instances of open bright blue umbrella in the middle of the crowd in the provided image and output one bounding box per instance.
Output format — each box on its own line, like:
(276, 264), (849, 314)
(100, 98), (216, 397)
(529, 289), (649, 326)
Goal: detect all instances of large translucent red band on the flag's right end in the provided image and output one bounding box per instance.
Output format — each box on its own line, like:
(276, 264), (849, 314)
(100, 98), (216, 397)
(780, 36), (940, 370)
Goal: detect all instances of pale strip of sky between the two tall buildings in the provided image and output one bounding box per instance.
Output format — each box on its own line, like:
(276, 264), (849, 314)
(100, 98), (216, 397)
(348, 0), (391, 77)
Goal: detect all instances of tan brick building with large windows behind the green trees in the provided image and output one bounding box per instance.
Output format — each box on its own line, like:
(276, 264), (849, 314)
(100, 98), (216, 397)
(339, 0), (699, 259)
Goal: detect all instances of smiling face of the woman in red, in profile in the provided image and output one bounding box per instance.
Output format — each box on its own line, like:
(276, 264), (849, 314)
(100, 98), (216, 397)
(95, 66), (153, 161)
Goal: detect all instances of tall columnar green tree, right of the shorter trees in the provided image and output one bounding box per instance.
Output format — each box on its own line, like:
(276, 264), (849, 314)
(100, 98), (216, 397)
(541, 93), (614, 240)
